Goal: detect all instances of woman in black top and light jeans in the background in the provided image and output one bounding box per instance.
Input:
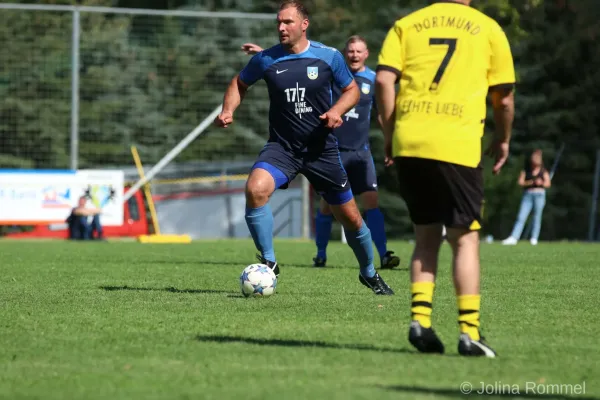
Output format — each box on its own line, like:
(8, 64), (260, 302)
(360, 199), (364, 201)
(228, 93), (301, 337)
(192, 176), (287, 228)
(502, 149), (550, 245)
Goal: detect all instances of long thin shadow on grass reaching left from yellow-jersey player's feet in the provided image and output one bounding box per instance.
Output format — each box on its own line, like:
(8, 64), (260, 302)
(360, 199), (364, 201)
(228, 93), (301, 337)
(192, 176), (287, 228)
(196, 335), (428, 357)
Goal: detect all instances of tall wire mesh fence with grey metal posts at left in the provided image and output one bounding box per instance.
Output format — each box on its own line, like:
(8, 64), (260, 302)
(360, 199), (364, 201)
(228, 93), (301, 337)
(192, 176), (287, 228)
(0, 4), (275, 169)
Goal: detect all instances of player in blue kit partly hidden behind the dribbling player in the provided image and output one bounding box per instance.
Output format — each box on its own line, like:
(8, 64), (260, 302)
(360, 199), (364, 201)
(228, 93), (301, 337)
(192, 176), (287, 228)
(242, 35), (400, 269)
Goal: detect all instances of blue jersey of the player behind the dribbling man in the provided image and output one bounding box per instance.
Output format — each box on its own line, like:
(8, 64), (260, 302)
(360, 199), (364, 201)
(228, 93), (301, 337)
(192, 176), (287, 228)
(333, 67), (377, 150)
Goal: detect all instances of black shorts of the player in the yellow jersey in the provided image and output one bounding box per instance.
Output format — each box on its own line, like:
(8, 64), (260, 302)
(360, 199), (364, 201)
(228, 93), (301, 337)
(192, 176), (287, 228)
(394, 157), (483, 230)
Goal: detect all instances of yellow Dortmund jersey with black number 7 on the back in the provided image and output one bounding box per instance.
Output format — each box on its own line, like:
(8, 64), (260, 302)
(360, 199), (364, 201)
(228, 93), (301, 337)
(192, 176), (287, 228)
(377, 0), (515, 167)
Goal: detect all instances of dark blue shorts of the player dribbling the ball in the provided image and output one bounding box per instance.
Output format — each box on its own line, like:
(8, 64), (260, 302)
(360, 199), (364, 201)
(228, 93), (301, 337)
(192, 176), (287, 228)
(252, 142), (353, 205)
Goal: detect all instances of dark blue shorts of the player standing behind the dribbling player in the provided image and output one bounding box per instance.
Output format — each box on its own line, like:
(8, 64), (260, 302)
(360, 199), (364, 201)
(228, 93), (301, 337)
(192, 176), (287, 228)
(340, 150), (377, 196)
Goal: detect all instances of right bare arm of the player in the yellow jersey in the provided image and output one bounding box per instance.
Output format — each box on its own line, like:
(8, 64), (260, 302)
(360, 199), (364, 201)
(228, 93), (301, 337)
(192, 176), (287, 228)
(487, 87), (515, 174)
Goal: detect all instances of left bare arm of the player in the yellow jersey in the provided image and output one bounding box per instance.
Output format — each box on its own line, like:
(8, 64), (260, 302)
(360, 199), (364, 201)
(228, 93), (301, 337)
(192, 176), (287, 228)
(375, 69), (398, 166)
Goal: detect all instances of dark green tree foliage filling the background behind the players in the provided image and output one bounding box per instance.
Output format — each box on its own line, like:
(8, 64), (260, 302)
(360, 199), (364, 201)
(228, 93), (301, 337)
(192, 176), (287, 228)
(0, 0), (600, 239)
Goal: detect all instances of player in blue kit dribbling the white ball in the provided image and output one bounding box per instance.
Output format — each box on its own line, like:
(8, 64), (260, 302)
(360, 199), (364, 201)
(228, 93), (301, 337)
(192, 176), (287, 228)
(215, 0), (394, 295)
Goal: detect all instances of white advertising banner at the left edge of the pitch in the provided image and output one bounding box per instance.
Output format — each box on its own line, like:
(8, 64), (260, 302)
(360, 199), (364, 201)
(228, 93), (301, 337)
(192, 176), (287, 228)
(0, 169), (124, 226)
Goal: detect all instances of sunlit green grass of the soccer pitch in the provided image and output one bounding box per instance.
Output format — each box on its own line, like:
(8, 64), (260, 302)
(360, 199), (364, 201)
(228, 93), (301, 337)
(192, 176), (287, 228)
(0, 241), (600, 400)
